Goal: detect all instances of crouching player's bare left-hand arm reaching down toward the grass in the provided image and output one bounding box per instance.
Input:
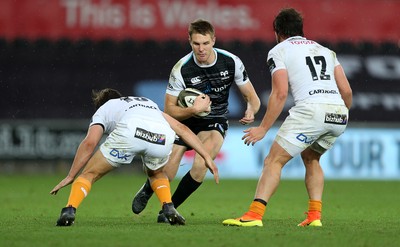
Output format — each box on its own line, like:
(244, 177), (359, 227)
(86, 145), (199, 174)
(50, 125), (104, 195)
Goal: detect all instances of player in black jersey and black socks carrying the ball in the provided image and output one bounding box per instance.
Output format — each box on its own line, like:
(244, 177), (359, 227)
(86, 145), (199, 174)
(132, 19), (260, 223)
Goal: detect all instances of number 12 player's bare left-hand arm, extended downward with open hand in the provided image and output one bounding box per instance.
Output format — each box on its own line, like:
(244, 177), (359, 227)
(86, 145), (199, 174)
(242, 69), (289, 145)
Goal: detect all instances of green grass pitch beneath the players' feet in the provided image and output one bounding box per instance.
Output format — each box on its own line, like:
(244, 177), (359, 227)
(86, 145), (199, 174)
(0, 173), (400, 247)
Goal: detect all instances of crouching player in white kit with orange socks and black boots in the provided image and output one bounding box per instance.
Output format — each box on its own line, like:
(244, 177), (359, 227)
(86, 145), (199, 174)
(50, 88), (219, 226)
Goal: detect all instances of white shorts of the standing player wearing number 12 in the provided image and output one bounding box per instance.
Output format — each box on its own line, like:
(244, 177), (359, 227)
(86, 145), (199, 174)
(275, 103), (349, 157)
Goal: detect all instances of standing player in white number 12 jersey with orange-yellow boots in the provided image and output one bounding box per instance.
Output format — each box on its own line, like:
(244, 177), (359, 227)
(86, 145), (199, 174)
(222, 8), (352, 226)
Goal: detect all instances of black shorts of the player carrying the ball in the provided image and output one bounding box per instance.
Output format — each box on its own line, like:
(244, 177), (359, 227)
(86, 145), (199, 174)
(174, 118), (229, 150)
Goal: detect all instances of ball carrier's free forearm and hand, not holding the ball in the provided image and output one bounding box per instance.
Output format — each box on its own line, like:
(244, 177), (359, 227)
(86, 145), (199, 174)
(239, 81), (260, 124)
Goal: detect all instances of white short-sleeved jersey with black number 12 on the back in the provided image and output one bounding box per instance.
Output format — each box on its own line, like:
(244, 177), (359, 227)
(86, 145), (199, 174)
(267, 36), (344, 105)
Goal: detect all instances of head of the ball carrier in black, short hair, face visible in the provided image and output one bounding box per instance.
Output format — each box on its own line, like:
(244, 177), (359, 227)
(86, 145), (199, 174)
(188, 19), (215, 64)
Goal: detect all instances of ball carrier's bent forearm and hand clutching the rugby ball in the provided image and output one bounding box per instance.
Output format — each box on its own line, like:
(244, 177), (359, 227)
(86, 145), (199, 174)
(164, 93), (211, 121)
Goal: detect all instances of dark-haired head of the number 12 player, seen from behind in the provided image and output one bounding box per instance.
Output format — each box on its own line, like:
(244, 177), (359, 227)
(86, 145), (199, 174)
(273, 8), (304, 42)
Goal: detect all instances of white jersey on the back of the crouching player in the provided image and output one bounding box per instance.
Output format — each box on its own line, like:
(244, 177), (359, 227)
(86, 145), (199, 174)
(89, 96), (166, 134)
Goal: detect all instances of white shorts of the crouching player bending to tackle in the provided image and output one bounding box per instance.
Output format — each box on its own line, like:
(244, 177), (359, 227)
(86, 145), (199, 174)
(100, 117), (175, 170)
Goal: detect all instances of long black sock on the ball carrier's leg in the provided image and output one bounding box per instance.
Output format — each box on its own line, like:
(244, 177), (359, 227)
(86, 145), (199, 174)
(172, 171), (202, 208)
